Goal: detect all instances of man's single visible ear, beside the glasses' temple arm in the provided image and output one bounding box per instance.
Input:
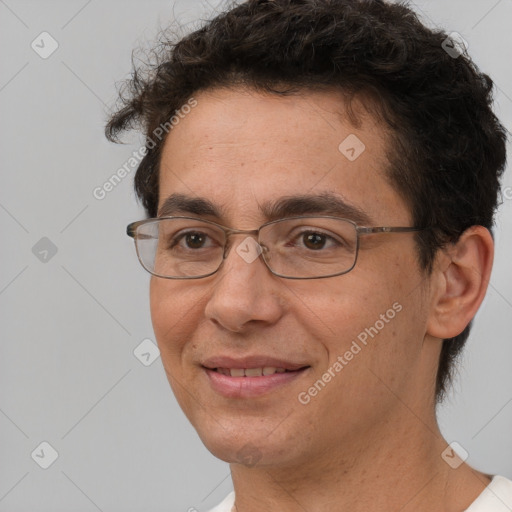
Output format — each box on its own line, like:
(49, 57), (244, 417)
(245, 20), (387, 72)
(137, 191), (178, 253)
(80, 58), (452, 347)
(427, 226), (494, 339)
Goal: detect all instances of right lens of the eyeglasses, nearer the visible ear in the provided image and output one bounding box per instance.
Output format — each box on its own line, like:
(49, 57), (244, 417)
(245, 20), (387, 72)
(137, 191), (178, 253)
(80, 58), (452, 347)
(260, 217), (357, 278)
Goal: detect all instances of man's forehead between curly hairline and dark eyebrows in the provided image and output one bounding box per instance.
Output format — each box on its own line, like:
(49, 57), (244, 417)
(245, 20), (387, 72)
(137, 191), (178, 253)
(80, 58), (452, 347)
(159, 89), (408, 226)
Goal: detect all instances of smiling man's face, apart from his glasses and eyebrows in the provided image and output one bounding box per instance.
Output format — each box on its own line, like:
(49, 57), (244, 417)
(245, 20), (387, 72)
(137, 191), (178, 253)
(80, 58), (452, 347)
(150, 89), (435, 465)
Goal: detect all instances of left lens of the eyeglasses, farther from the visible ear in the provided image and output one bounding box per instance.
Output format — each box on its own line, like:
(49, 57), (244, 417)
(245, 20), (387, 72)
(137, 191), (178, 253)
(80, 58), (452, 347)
(135, 218), (225, 278)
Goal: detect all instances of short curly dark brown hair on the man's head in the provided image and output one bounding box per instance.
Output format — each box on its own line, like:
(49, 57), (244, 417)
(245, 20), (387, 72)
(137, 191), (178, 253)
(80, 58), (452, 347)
(105, 0), (507, 402)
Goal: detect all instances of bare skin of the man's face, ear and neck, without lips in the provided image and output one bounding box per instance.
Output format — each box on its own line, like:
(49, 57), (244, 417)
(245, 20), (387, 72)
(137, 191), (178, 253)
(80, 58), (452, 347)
(150, 88), (493, 512)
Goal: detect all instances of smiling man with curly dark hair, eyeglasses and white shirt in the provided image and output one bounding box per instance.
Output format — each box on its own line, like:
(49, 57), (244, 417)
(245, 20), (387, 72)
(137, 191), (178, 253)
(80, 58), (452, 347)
(107, 0), (512, 512)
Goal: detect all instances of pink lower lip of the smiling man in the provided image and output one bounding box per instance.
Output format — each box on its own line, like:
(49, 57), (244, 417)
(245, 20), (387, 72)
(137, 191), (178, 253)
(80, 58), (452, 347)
(204, 368), (308, 398)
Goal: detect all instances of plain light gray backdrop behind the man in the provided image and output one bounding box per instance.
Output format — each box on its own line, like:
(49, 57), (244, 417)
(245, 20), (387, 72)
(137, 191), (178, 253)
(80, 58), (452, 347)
(0, 0), (512, 512)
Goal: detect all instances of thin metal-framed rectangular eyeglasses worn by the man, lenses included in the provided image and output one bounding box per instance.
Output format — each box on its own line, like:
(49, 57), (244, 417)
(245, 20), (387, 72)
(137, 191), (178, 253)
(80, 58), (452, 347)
(126, 216), (422, 279)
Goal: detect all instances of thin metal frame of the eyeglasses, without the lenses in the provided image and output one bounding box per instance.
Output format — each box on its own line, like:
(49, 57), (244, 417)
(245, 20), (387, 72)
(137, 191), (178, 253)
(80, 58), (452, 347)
(126, 215), (426, 279)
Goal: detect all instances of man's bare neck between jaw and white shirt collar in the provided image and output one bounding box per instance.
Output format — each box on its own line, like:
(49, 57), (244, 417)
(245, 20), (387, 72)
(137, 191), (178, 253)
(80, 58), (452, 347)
(231, 406), (490, 512)
